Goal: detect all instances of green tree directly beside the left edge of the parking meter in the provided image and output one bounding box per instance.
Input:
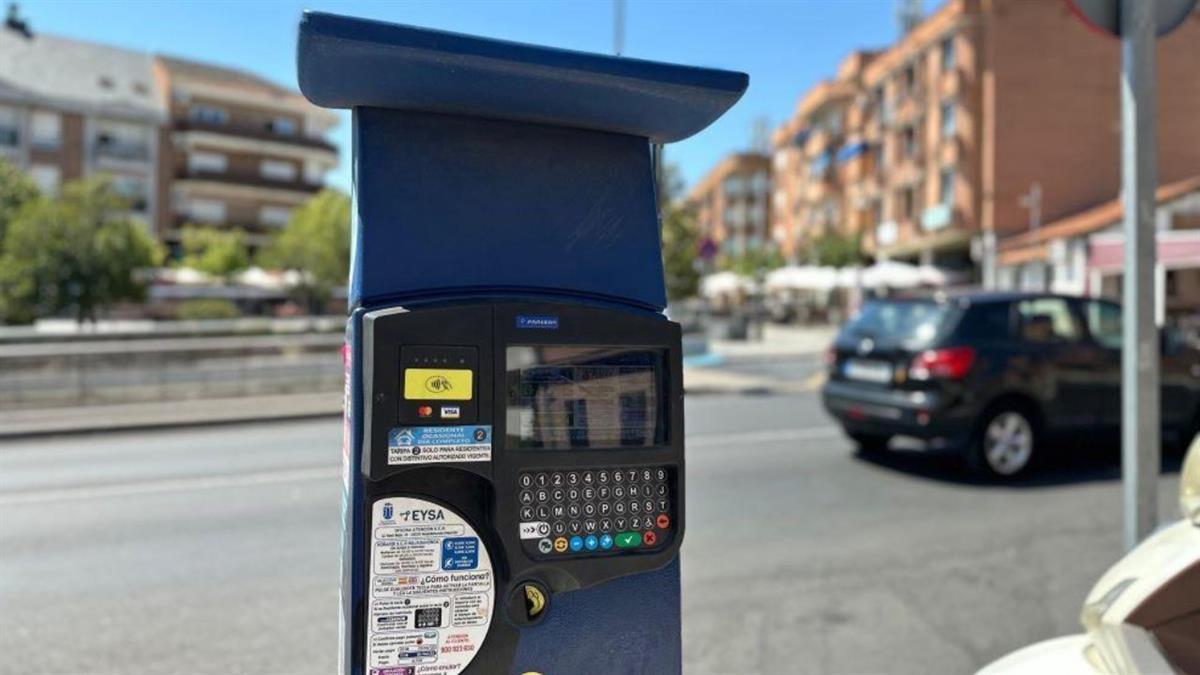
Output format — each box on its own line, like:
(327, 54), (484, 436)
(262, 190), (350, 313)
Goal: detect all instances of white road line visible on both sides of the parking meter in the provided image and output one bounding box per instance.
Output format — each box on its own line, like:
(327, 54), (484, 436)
(0, 425), (839, 507)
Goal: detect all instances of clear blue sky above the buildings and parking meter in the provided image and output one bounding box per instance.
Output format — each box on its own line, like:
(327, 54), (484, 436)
(20, 0), (937, 189)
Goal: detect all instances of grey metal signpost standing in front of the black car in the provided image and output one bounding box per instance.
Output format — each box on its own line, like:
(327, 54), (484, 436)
(1121, 0), (1160, 549)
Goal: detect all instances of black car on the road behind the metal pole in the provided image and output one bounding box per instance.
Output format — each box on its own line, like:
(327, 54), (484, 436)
(822, 292), (1200, 477)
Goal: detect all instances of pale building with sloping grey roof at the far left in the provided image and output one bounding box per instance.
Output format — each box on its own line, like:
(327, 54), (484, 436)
(0, 16), (167, 224)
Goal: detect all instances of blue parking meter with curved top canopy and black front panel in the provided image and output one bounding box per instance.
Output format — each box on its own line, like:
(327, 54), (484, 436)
(299, 13), (748, 675)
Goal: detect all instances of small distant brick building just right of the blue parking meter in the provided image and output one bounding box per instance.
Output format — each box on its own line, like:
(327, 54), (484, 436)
(684, 153), (770, 257)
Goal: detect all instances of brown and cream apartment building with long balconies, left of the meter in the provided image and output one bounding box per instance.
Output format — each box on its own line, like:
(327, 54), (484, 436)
(156, 56), (337, 250)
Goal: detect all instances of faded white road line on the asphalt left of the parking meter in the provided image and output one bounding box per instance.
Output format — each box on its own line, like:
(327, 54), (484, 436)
(0, 466), (342, 507)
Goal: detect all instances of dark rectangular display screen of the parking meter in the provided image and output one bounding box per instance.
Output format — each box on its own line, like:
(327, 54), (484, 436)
(506, 345), (667, 449)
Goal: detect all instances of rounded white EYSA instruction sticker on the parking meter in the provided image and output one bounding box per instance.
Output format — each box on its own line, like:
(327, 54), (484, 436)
(366, 497), (496, 675)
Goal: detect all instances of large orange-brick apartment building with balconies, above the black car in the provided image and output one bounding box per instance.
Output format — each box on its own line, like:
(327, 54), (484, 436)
(775, 0), (1200, 282)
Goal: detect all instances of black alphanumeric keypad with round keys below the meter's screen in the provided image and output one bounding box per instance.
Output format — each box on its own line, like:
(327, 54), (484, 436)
(517, 466), (674, 558)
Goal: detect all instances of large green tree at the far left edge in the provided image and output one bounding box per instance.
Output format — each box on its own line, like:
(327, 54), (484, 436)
(0, 177), (162, 323)
